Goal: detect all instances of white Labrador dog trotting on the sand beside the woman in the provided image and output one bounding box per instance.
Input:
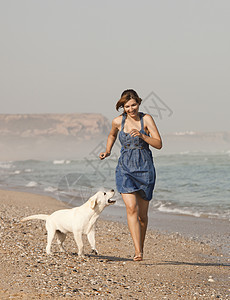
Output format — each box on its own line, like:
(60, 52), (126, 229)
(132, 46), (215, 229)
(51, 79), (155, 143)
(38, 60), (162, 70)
(21, 190), (116, 256)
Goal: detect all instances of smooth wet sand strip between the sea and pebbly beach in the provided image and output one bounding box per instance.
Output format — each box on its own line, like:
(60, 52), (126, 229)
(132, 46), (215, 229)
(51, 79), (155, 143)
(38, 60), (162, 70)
(0, 187), (230, 261)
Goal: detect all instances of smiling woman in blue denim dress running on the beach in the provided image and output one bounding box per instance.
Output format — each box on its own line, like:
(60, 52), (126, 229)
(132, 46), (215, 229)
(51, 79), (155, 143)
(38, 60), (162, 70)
(100, 90), (162, 261)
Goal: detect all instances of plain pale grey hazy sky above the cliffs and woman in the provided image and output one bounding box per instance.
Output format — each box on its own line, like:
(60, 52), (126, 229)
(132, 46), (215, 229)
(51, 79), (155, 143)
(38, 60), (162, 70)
(0, 0), (230, 133)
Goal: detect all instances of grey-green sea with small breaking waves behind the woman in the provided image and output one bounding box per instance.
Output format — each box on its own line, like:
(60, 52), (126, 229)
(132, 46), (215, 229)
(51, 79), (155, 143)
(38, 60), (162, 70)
(0, 151), (230, 220)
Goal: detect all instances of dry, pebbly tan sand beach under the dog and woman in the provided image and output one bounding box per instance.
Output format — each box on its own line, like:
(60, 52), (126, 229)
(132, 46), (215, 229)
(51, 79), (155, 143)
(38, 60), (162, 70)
(0, 190), (230, 299)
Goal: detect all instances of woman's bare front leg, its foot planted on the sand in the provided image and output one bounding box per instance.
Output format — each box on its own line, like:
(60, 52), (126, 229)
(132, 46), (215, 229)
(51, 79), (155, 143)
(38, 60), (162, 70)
(122, 193), (142, 256)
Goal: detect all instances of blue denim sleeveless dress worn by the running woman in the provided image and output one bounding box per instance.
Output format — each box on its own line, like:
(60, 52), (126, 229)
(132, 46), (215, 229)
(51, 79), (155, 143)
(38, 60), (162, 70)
(116, 113), (156, 201)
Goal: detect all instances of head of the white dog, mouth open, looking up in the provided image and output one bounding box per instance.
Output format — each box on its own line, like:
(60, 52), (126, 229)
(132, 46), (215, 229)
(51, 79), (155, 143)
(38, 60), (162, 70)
(89, 190), (116, 211)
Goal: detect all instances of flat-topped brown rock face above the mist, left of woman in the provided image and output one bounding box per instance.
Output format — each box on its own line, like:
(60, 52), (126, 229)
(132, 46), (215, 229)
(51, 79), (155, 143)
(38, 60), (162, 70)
(0, 114), (110, 139)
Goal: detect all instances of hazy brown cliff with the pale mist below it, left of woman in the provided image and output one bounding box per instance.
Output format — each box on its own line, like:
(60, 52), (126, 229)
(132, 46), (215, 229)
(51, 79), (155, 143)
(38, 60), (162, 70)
(0, 114), (111, 161)
